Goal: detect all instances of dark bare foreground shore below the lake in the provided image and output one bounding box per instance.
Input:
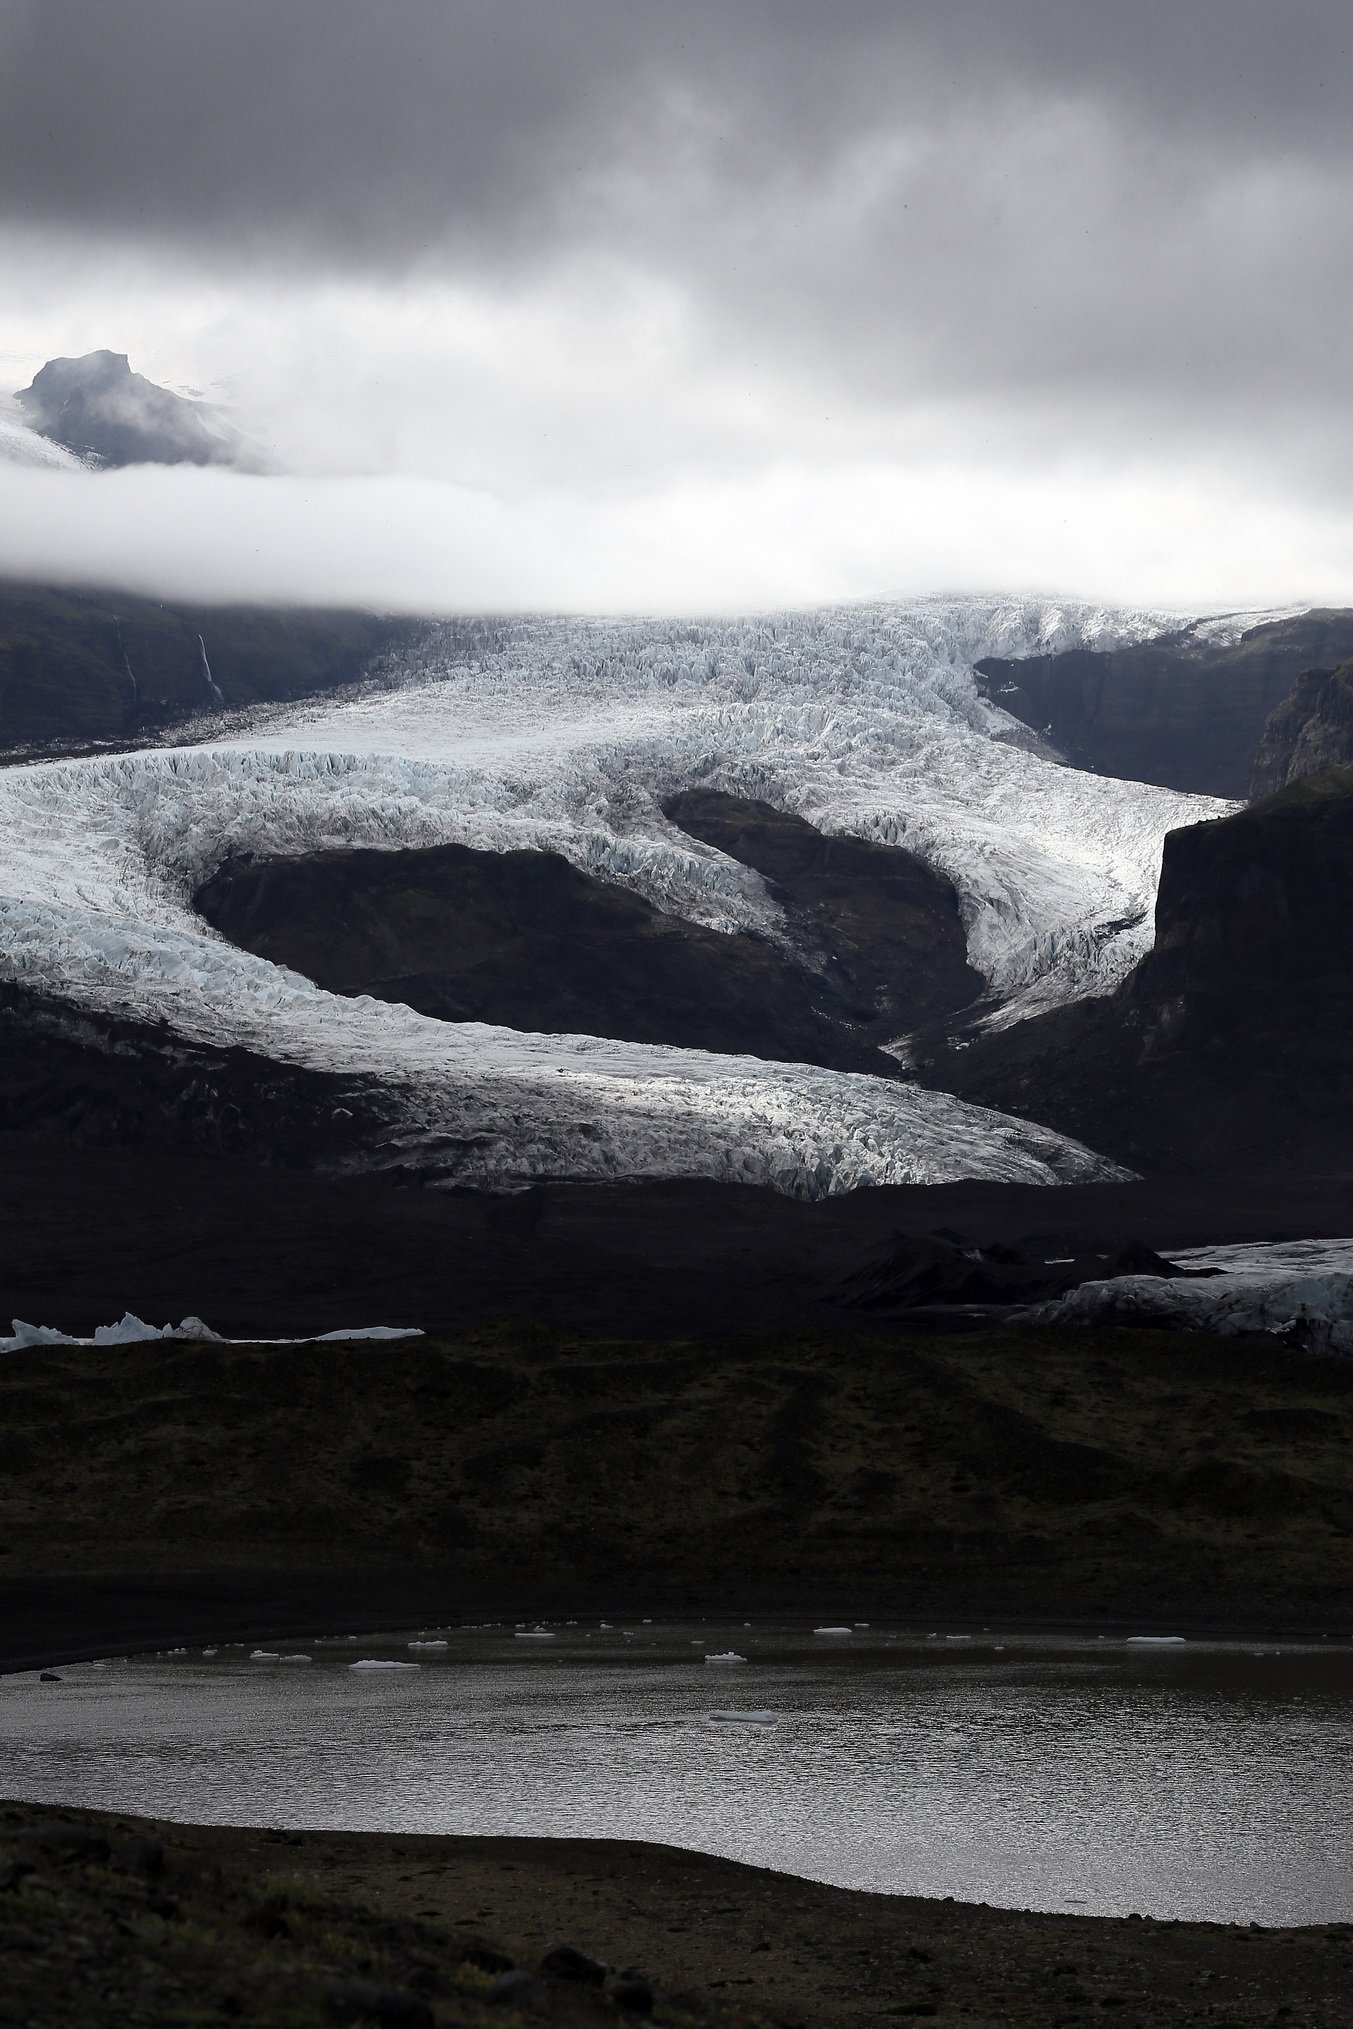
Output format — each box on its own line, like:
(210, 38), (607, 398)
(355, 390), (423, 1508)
(0, 1804), (1353, 2029)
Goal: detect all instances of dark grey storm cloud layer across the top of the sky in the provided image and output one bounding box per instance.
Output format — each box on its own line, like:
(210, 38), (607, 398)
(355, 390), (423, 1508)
(0, 0), (1353, 454)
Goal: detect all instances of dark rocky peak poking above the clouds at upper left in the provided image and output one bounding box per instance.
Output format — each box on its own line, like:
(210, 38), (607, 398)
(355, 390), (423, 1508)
(16, 351), (239, 467)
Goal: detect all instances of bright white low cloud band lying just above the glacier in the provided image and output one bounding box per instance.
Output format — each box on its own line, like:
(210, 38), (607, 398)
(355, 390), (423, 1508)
(0, 463), (1353, 613)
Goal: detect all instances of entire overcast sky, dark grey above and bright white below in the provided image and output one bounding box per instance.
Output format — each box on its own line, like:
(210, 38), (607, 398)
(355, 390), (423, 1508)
(0, 0), (1353, 607)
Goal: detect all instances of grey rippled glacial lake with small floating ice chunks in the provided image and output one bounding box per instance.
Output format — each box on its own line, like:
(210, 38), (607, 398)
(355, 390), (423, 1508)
(0, 1621), (1353, 1923)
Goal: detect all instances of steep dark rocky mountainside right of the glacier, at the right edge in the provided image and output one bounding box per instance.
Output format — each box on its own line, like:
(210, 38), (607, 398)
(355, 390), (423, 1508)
(923, 769), (1353, 1175)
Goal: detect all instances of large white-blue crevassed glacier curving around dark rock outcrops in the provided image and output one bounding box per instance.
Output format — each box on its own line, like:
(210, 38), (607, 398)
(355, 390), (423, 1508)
(0, 599), (1254, 1197)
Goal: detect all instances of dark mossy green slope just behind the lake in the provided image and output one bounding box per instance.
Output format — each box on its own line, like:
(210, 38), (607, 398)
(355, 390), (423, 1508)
(0, 1327), (1353, 1631)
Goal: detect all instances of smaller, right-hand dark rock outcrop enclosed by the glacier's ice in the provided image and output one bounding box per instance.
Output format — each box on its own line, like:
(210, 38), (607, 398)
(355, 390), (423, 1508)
(663, 789), (984, 1041)
